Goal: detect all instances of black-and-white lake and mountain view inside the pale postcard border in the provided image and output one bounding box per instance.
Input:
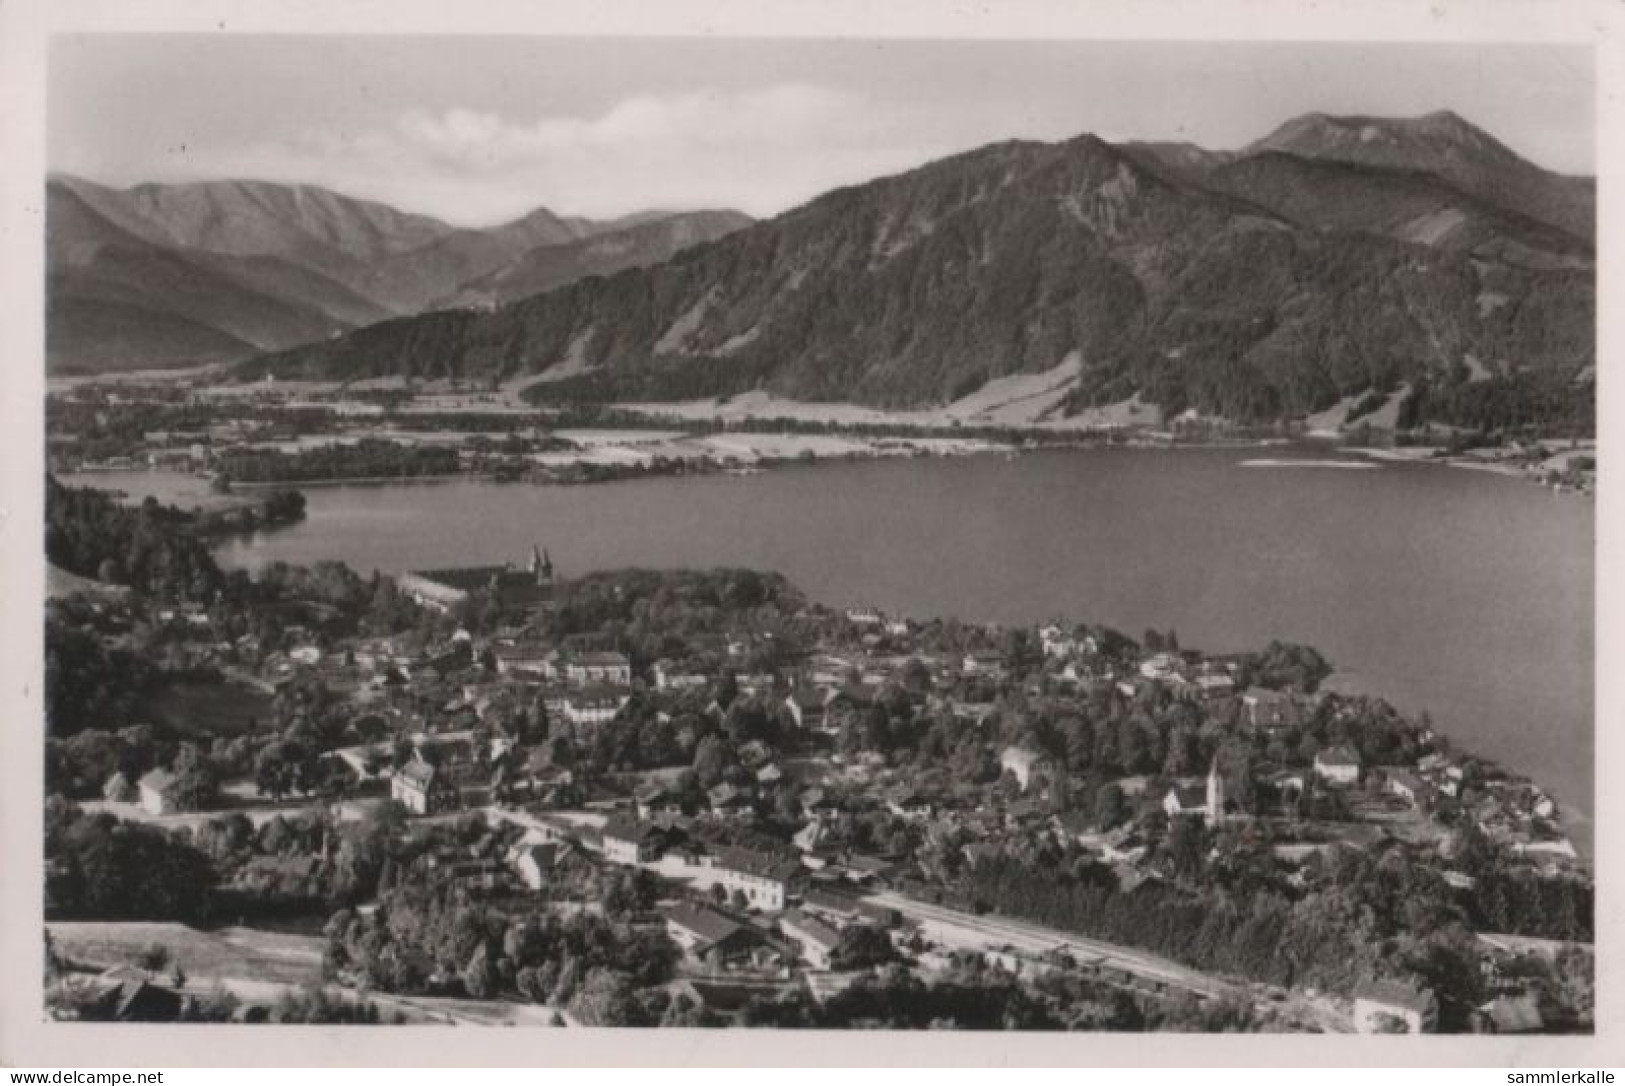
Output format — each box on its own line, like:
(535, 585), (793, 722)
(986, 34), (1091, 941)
(7, 5), (1617, 1060)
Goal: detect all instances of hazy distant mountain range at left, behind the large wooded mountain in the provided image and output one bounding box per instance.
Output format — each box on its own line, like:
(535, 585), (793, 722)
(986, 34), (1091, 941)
(46, 176), (749, 372)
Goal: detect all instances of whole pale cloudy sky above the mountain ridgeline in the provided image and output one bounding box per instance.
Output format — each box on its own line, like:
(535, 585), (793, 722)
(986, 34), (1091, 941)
(47, 34), (1596, 224)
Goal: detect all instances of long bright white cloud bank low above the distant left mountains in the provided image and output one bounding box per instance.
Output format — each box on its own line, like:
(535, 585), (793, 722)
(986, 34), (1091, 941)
(192, 83), (962, 223)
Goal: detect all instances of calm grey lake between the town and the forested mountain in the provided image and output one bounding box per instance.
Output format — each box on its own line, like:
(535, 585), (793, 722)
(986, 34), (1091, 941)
(73, 449), (1594, 844)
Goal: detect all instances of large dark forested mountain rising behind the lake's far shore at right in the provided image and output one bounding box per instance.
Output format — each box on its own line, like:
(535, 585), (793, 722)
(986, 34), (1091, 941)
(239, 114), (1596, 419)
